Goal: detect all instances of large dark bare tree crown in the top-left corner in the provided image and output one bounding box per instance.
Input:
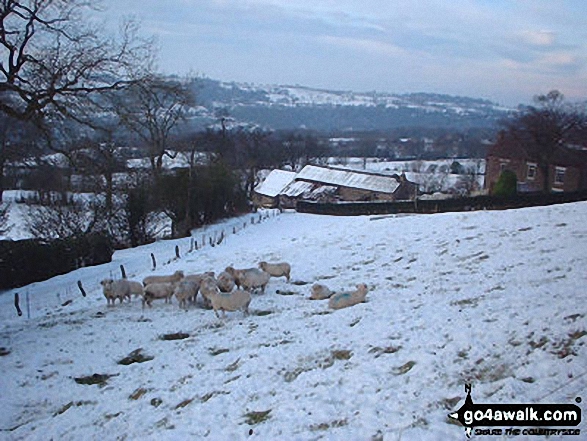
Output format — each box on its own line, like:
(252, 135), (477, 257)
(0, 0), (152, 124)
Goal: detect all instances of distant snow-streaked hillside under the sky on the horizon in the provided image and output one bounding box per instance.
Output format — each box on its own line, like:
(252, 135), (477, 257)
(193, 78), (511, 131)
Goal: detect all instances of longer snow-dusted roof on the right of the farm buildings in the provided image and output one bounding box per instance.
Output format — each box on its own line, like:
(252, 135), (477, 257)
(295, 165), (399, 193)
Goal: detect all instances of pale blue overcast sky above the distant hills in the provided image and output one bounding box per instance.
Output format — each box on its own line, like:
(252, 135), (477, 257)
(105, 0), (587, 105)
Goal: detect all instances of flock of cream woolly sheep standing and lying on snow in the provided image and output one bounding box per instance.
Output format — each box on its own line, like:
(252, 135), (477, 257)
(100, 262), (368, 317)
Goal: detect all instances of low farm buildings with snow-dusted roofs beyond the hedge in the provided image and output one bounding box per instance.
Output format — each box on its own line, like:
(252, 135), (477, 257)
(254, 165), (418, 208)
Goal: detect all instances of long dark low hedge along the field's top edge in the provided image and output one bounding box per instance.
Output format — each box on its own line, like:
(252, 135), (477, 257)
(296, 191), (587, 216)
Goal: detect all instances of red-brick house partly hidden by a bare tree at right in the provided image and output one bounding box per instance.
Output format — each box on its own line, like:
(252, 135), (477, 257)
(485, 140), (587, 193)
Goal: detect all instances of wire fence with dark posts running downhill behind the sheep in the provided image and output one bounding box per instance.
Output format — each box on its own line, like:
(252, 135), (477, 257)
(0, 210), (279, 318)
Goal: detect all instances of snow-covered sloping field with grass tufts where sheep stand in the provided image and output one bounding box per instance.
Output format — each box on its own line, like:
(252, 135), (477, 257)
(0, 202), (587, 441)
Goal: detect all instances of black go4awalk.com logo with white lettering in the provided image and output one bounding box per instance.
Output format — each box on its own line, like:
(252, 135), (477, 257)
(449, 384), (581, 438)
